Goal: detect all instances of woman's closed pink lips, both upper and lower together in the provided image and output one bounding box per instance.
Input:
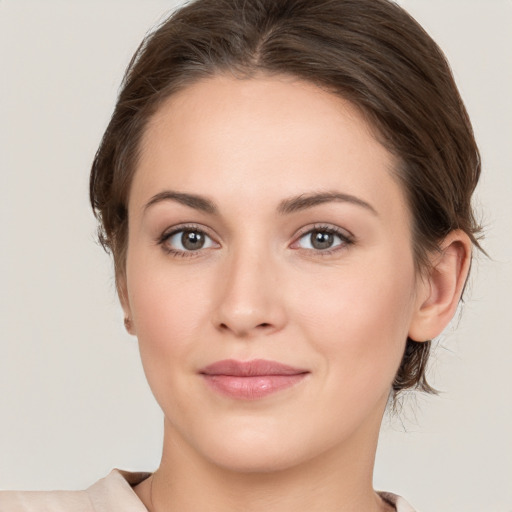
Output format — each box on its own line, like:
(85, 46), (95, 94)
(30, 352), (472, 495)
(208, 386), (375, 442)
(199, 359), (310, 400)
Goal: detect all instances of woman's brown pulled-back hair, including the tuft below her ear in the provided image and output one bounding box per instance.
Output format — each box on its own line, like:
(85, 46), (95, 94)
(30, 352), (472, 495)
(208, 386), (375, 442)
(90, 0), (480, 392)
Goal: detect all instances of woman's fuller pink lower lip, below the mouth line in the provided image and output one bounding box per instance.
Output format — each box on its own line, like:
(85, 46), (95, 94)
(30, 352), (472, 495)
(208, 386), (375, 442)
(203, 373), (307, 400)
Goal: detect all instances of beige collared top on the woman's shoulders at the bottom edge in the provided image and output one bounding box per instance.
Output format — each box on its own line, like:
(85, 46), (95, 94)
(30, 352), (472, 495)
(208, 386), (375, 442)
(0, 469), (414, 512)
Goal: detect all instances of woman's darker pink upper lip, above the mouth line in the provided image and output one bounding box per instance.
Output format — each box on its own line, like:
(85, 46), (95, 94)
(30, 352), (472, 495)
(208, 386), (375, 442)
(199, 359), (308, 377)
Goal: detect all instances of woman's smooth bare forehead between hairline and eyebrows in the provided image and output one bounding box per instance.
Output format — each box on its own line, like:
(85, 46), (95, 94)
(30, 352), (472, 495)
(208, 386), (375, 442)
(130, 76), (405, 224)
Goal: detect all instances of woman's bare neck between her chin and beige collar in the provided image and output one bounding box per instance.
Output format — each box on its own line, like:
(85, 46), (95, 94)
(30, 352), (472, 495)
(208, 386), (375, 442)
(138, 410), (389, 512)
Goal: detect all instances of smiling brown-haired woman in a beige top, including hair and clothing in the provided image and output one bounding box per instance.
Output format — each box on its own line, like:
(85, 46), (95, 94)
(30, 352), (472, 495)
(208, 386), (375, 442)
(0, 0), (480, 512)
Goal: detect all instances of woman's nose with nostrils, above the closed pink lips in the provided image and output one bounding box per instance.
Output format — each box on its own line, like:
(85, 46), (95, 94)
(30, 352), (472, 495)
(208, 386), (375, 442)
(213, 246), (286, 338)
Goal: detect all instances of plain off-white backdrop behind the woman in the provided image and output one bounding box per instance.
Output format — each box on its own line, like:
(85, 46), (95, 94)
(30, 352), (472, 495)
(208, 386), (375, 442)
(0, 0), (512, 512)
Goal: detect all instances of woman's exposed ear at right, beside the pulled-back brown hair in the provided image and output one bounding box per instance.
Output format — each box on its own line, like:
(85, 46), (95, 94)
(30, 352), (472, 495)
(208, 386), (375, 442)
(409, 229), (472, 341)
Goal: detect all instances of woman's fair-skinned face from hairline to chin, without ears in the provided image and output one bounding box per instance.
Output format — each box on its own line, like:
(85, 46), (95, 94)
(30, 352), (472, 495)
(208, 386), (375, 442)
(122, 77), (422, 471)
